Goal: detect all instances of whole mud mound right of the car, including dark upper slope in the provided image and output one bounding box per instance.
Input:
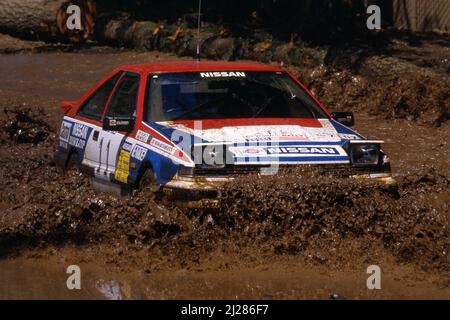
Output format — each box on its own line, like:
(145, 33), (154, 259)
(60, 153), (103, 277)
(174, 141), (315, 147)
(293, 34), (450, 126)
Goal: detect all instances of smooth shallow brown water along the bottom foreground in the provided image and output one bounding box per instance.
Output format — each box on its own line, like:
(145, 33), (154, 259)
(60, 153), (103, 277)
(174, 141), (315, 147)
(0, 257), (450, 300)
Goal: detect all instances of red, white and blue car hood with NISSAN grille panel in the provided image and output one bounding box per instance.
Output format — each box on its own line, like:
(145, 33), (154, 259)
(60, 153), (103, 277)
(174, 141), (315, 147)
(147, 118), (363, 164)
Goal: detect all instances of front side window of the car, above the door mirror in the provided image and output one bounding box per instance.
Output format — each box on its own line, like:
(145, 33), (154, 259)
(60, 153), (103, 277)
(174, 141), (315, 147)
(106, 73), (139, 117)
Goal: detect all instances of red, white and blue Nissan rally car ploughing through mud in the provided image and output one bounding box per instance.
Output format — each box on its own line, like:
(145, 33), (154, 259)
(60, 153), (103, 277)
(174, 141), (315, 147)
(54, 61), (395, 205)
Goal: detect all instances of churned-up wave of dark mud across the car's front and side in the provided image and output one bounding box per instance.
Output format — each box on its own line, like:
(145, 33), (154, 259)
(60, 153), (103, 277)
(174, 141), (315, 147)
(0, 112), (450, 273)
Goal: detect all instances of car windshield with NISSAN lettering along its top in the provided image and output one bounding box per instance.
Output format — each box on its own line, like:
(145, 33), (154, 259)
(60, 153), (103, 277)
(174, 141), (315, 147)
(144, 71), (328, 121)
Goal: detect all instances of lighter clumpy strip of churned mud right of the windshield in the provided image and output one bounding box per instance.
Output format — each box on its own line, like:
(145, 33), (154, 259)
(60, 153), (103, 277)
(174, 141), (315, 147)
(296, 64), (450, 126)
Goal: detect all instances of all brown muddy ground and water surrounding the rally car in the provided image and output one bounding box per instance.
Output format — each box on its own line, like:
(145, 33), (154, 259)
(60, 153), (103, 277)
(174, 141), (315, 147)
(0, 43), (450, 299)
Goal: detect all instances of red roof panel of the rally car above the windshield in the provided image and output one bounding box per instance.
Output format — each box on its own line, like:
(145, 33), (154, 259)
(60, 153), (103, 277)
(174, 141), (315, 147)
(119, 60), (283, 73)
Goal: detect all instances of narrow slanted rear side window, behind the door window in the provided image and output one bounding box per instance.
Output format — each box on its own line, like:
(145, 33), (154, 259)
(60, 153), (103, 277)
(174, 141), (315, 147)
(78, 72), (122, 121)
